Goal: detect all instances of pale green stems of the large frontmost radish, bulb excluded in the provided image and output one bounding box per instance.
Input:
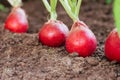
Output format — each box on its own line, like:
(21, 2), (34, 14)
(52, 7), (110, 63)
(59, 0), (82, 22)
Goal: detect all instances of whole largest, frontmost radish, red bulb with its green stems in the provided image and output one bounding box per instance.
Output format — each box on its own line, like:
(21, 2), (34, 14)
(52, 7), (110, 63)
(60, 0), (97, 57)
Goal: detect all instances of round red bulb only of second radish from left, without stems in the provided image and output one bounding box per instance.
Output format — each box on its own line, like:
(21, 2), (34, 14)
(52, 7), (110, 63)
(39, 20), (68, 47)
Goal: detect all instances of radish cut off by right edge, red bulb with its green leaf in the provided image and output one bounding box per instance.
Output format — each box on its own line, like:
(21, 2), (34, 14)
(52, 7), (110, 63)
(105, 0), (120, 62)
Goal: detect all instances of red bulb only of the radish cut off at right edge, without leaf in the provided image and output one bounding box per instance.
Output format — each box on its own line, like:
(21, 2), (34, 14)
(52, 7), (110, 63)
(105, 29), (120, 61)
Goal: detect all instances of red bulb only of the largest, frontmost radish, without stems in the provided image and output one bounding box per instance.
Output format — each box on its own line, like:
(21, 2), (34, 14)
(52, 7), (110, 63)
(66, 21), (97, 57)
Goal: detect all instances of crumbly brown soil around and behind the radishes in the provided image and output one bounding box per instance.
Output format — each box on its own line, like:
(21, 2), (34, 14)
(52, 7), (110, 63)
(0, 0), (120, 80)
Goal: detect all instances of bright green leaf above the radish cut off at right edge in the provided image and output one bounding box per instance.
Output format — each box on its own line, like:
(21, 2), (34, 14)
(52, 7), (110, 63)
(113, 0), (120, 34)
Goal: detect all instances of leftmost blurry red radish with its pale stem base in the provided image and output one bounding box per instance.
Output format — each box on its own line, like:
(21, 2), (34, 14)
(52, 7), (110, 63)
(5, 0), (28, 33)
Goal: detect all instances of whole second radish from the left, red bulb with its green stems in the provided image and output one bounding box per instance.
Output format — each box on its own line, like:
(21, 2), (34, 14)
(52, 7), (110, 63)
(39, 0), (69, 47)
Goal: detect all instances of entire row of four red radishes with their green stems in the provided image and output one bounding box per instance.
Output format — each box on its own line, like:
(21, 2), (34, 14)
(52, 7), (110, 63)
(5, 0), (120, 61)
